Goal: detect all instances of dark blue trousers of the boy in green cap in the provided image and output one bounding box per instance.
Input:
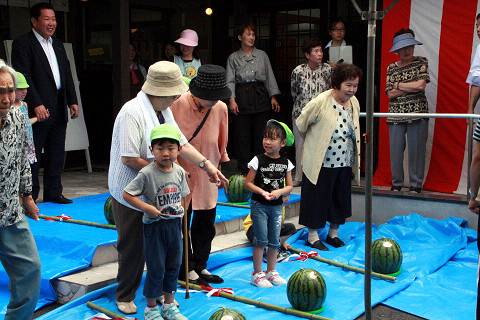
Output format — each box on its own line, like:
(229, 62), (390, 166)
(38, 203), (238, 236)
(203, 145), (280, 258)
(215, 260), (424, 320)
(143, 219), (183, 299)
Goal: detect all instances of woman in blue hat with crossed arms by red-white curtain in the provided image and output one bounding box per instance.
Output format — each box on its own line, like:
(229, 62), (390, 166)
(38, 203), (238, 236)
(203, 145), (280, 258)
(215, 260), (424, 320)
(385, 29), (430, 193)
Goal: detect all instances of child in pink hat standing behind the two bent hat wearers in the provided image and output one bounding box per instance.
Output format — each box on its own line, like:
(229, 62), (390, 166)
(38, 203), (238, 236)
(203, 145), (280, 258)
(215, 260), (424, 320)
(173, 29), (202, 79)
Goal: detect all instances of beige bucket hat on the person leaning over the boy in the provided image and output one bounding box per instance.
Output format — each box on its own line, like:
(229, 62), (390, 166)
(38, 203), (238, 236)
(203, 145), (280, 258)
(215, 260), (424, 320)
(142, 61), (188, 97)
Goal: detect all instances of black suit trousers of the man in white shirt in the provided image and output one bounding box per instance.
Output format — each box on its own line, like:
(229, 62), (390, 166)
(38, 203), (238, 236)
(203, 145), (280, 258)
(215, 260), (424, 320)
(31, 97), (67, 201)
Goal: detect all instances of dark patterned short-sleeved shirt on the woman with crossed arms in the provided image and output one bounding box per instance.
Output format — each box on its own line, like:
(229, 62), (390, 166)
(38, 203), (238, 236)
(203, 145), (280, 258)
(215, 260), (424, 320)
(385, 57), (430, 123)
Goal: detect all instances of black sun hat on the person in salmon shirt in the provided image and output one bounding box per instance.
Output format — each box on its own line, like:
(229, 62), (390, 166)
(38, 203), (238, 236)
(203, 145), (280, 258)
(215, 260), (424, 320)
(190, 64), (232, 100)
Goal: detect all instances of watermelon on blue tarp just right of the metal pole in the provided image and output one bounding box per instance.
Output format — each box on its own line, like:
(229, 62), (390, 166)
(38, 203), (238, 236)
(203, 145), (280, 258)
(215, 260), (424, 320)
(372, 237), (402, 274)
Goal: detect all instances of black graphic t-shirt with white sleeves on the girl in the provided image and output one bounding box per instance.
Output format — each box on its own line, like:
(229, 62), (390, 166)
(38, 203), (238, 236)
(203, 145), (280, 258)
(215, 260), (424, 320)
(248, 153), (294, 206)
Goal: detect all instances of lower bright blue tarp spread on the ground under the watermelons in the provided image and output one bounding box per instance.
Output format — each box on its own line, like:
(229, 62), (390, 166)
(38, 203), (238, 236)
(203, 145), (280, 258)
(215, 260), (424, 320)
(34, 214), (476, 320)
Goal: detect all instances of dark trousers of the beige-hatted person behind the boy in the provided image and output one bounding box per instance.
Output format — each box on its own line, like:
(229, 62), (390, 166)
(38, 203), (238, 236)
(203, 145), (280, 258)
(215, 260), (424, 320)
(112, 198), (145, 302)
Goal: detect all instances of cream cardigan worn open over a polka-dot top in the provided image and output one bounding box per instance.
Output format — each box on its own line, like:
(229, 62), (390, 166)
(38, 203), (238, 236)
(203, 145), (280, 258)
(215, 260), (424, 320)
(296, 89), (360, 184)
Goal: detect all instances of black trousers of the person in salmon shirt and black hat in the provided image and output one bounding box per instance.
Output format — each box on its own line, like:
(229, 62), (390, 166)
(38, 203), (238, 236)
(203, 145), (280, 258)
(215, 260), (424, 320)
(179, 203), (217, 279)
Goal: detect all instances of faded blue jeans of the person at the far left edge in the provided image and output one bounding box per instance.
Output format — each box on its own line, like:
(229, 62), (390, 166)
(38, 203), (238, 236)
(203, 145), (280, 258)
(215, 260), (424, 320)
(0, 217), (41, 320)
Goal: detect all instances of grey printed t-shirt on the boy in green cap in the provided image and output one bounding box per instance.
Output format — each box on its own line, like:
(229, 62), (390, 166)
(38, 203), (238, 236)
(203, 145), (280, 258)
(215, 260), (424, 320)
(125, 162), (190, 223)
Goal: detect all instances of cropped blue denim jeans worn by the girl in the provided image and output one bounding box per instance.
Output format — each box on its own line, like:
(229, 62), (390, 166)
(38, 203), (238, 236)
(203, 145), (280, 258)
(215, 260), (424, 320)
(250, 200), (283, 248)
